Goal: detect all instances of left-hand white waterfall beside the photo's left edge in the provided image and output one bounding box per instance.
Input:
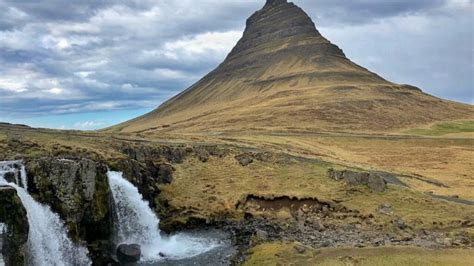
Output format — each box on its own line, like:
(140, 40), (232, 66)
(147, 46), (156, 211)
(0, 161), (91, 266)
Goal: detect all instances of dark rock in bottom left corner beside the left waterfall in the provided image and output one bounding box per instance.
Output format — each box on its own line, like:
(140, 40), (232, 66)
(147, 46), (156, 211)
(0, 186), (29, 266)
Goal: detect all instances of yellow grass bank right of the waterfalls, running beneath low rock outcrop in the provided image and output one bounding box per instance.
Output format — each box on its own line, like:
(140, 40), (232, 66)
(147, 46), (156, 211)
(160, 157), (474, 228)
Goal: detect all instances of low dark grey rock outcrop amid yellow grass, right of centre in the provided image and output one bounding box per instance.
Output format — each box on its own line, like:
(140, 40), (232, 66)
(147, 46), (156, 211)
(327, 168), (387, 192)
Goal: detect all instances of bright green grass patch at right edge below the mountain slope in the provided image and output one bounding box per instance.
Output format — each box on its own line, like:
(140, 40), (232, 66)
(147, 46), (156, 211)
(405, 120), (474, 136)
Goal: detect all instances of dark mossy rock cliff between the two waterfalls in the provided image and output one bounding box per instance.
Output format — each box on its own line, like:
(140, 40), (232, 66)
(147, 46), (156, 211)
(26, 157), (112, 259)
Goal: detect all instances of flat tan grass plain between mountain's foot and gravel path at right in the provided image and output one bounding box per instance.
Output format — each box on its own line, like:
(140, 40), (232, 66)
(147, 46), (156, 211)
(210, 134), (474, 200)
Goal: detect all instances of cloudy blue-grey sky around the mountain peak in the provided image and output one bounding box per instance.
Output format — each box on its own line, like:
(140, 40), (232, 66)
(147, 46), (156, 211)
(0, 0), (474, 129)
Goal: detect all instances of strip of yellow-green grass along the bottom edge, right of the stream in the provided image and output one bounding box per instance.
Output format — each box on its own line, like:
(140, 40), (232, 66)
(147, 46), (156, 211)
(244, 242), (474, 266)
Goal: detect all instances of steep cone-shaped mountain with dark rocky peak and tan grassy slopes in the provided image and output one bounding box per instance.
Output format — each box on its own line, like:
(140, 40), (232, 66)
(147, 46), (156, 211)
(111, 0), (474, 133)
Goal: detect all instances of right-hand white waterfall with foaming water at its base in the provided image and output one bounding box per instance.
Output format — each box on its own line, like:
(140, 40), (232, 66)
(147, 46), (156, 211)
(107, 171), (219, 262)
